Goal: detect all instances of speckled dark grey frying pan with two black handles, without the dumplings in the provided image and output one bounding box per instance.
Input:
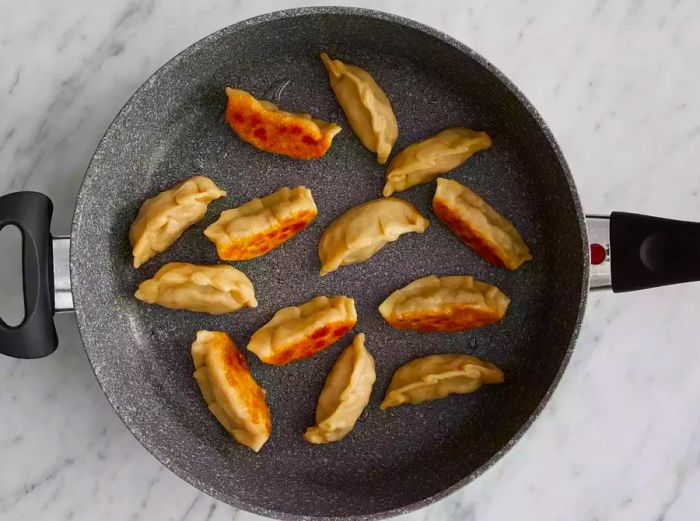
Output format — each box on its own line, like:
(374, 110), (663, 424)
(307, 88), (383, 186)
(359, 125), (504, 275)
(0, 7), (700, 519)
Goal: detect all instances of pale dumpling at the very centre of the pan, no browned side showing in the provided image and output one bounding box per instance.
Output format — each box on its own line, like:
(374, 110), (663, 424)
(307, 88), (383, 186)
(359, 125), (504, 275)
(318, 197), (429, 275)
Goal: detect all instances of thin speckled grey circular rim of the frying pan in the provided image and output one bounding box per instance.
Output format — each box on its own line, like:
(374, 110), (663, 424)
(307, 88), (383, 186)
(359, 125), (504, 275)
(70, 6), (590, 521)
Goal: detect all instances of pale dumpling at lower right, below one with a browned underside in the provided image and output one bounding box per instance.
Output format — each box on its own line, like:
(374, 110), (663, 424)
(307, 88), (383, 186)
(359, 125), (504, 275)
(379, 355), (503, 409)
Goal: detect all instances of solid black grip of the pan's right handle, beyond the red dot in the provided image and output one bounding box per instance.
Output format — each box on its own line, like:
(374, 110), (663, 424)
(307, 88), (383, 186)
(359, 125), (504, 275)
(610, 212), (700, 292)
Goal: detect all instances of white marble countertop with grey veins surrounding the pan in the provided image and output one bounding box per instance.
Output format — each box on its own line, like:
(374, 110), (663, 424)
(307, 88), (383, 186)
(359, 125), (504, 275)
(0, 0), (700, 521)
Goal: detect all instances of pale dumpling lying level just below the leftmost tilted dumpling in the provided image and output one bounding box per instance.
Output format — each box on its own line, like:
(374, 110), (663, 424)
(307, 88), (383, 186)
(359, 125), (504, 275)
(135, 262), (258, 315)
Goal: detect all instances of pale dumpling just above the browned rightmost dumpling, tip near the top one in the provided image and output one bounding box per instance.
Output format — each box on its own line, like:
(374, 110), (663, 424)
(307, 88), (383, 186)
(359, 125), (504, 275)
(384, 127), (491, 197)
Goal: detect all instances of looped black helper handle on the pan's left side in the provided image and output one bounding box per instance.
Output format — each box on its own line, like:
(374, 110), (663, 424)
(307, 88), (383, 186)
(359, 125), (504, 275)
(0, 192), (58, 358)
